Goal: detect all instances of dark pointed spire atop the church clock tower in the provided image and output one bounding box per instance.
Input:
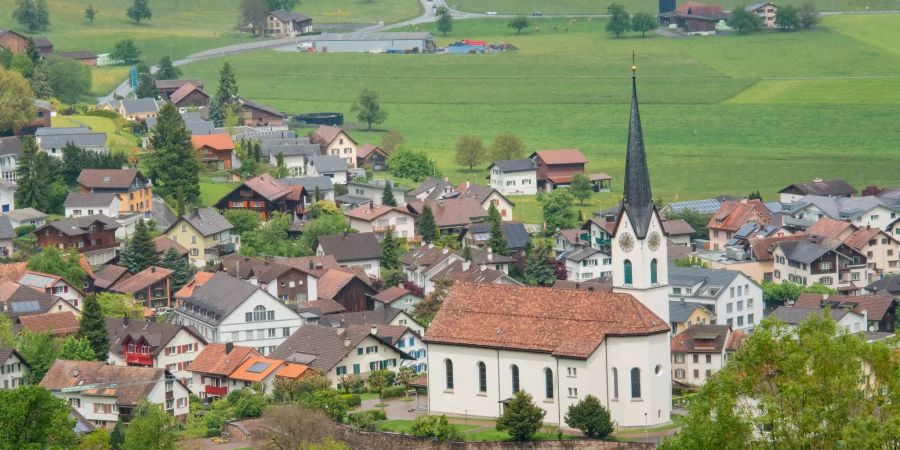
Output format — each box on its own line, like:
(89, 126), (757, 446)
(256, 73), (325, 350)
(622, 62), (654, 243)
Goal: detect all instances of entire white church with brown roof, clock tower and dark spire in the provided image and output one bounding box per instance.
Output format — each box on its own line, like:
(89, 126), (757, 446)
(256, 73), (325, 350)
(425, 67), (672, 427)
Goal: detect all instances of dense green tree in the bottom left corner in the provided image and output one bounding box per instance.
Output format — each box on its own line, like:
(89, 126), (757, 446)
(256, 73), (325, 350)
(0, 386), (78, 449)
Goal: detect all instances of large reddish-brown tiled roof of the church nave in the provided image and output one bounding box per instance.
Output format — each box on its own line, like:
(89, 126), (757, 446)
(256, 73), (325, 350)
(425, 283), (669, 359)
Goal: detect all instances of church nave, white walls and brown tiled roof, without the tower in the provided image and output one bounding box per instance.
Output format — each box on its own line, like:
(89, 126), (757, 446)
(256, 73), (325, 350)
(425, 283), (671, 426)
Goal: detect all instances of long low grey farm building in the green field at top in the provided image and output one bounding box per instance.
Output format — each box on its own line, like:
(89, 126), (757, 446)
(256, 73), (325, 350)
(300, 32), (435, 53)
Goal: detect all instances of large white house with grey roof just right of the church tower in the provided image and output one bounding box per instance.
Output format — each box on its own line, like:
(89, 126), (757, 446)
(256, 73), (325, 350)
(669, 266), (764, 330)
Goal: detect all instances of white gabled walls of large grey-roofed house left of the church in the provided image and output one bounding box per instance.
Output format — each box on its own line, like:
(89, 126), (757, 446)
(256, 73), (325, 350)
(175, 289), (303, 355)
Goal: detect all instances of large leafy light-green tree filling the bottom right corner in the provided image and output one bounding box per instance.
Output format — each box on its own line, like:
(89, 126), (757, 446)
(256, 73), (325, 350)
(659, 311), (900, 450)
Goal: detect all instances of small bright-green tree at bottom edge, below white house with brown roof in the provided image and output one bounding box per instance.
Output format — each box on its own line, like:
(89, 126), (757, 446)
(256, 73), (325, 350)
(122, 400), (178, 450)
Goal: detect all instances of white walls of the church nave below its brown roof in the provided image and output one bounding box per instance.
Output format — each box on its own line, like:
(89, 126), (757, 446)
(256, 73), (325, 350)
(428, 333), (672, 427)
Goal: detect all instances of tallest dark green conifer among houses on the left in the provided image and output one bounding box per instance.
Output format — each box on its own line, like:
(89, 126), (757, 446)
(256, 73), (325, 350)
(145, 102), (200, 204)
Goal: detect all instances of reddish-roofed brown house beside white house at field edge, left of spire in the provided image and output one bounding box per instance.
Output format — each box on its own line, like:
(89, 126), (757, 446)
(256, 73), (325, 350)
(528, 148), (612, 192)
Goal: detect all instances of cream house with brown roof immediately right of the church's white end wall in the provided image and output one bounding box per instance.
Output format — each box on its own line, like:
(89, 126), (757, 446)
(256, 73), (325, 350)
(671, 324), (744, 387)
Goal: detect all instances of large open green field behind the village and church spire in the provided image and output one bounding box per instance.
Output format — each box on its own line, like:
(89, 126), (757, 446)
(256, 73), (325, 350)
(185, 15), (900, 206)
